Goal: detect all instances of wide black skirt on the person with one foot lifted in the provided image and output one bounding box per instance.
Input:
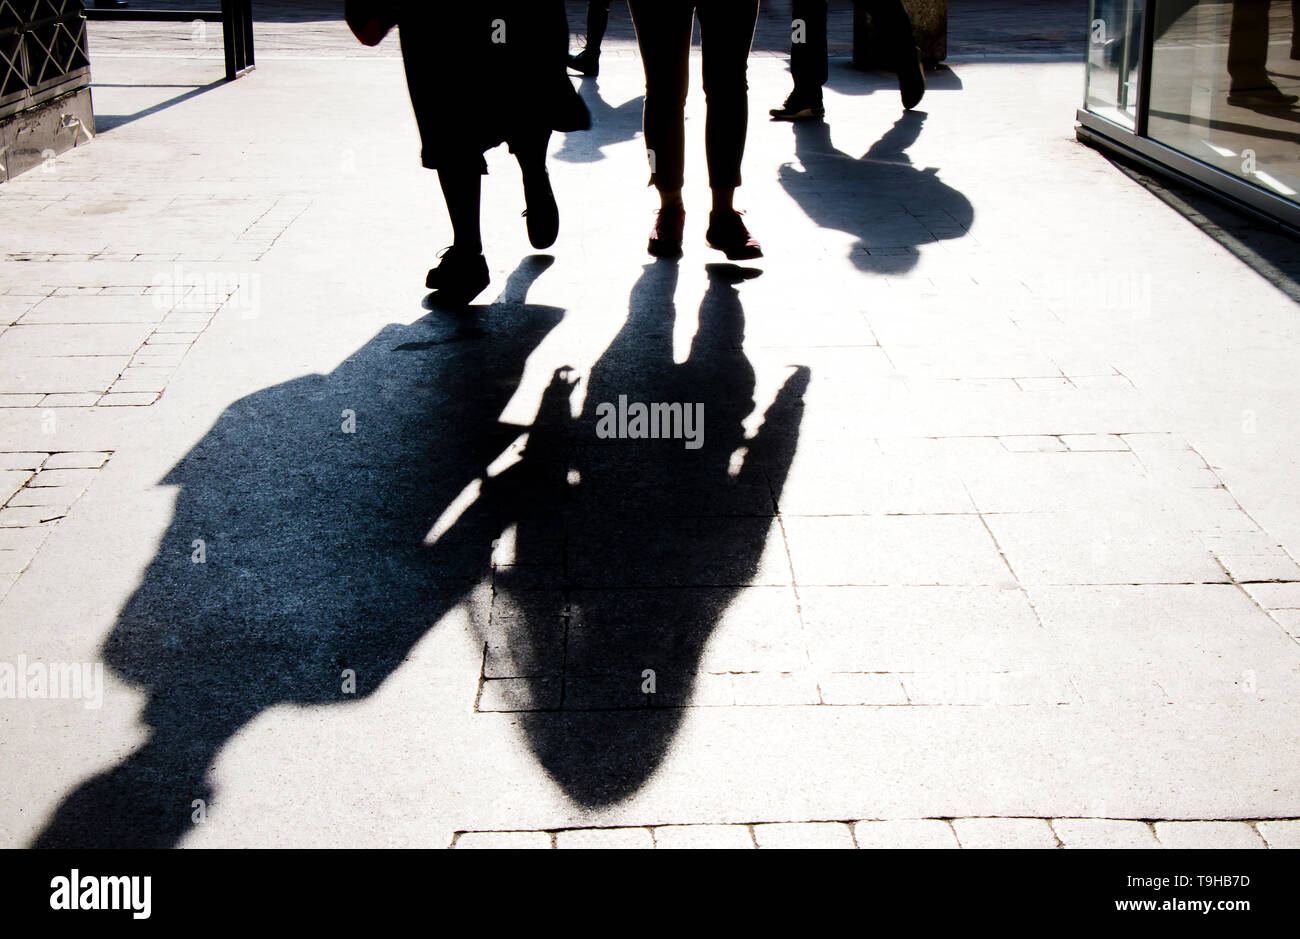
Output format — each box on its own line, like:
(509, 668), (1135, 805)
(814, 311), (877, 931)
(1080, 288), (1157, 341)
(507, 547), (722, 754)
(398, 0), (592, 172)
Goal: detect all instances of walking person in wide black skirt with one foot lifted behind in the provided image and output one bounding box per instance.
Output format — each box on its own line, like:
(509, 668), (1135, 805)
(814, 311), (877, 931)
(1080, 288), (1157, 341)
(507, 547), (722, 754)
(348, 0), (590, 306)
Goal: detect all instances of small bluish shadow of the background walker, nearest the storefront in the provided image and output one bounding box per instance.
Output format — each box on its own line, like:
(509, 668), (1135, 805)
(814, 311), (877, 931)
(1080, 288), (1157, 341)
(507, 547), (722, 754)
(780, 111), (975, 274)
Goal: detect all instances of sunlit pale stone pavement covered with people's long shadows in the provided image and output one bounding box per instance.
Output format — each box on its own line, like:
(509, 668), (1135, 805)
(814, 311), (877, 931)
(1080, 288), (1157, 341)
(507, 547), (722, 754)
(0, 7), (1300, 848)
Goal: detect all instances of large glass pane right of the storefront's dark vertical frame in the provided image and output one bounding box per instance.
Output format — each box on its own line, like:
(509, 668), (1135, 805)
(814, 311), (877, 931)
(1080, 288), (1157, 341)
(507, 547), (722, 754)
(1148, 0), (1300, 200)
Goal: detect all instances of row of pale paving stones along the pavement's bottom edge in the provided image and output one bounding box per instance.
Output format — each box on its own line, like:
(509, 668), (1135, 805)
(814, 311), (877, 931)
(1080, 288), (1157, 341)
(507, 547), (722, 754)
(449, 818), (1300, 849)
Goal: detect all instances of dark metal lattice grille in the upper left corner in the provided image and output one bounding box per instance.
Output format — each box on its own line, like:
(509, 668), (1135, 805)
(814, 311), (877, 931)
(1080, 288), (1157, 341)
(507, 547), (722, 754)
(0, 0), (90, 118)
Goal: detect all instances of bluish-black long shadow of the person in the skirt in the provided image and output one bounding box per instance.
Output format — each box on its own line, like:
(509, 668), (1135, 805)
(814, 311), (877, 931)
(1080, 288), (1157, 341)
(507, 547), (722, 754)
(34, 258), (563, 847)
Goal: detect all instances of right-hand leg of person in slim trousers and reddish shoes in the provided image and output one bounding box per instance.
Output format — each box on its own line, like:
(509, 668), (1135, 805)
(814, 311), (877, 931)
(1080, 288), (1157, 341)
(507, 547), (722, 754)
(697, 0), (763, 260)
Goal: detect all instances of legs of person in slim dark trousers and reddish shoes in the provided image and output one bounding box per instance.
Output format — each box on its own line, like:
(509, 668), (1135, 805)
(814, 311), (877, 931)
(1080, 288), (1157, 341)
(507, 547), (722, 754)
(629, 0), (763, 260)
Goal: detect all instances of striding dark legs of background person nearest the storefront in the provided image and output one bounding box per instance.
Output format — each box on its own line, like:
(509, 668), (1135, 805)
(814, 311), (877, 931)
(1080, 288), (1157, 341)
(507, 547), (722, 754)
(768, 0), (926, 121)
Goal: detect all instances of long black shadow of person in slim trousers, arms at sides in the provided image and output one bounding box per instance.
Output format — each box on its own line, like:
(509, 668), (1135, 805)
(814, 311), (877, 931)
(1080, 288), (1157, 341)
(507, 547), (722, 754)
(473, 261), (810, 808)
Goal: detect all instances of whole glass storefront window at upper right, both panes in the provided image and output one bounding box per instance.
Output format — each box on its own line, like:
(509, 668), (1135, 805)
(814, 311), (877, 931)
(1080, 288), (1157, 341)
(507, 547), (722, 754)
(1079, 0), (1300, 224)
